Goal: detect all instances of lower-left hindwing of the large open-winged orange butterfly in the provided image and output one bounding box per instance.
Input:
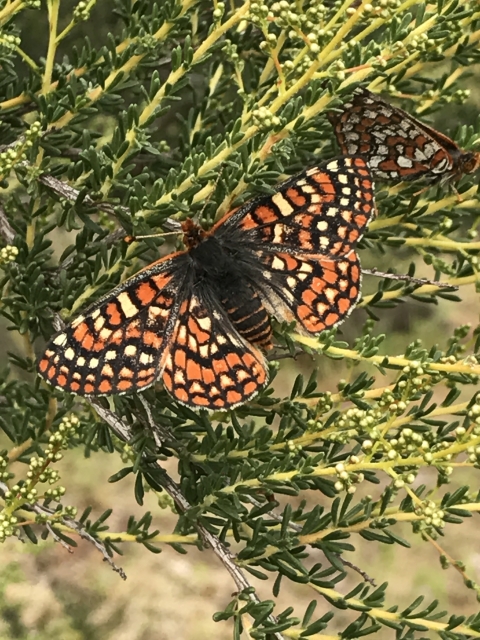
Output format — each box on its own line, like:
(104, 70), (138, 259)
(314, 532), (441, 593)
(163, 292), (268, 410)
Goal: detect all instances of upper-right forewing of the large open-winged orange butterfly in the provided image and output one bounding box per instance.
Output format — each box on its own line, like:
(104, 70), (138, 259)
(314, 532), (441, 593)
(216, 157), (375, 256)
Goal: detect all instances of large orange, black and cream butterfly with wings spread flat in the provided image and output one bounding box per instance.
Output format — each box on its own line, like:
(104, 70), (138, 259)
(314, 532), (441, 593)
(38, 157), (375, 410)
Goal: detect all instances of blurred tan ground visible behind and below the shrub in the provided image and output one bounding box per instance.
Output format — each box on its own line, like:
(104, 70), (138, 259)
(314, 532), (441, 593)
(0, 2), (480, 640)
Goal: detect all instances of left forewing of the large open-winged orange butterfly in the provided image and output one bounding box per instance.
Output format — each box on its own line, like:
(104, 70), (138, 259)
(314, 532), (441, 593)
(38, 252), (188, 395)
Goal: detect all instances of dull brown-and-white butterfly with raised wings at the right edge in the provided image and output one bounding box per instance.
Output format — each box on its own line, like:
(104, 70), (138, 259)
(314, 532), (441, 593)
(328, 88), (480, 182)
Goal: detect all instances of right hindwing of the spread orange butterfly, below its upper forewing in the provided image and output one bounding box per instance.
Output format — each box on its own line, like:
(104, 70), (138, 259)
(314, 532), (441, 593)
(264, 250), (362, 334)
